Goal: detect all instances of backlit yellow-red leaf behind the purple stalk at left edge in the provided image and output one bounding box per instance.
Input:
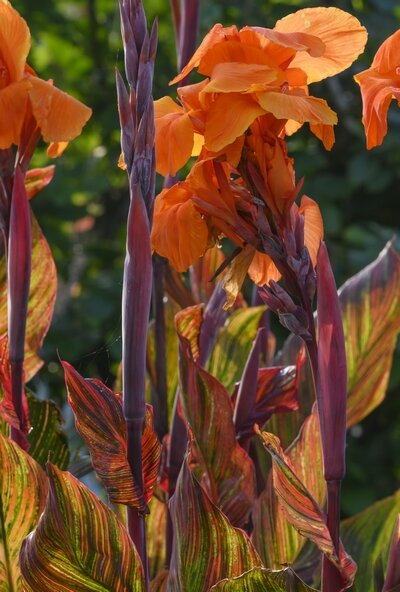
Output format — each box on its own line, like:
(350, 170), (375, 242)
(0, 216), (57, 382)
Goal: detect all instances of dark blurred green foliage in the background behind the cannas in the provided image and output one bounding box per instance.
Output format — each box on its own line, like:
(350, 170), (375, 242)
(14, 0), (400, 514)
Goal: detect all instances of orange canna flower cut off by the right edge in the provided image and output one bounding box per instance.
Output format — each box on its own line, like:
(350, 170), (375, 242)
(354, 29), (400, 150)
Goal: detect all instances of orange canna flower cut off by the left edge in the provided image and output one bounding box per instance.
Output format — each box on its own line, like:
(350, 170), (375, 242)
(0, 0), (92, 156)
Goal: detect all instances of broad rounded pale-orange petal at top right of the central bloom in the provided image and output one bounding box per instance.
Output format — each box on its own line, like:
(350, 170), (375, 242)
(275, 6), (368, 83)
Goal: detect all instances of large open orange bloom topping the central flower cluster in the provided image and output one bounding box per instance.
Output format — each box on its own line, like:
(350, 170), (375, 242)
(156, 7), (367, 172)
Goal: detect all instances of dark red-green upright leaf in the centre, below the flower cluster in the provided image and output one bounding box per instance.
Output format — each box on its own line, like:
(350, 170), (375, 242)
(177, 320), (255, 526)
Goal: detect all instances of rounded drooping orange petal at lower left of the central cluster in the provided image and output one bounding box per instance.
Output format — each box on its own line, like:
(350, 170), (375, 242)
(151, 183), (209, 271)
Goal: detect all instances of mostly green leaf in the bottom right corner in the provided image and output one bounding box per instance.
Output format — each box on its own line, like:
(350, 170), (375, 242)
(341, 489), (400, 592)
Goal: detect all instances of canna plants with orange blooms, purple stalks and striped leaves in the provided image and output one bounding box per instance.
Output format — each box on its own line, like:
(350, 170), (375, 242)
(0, 0), (400, 592)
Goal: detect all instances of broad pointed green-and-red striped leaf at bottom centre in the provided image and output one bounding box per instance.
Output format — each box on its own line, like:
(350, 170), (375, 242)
(167, 450), (262, 592)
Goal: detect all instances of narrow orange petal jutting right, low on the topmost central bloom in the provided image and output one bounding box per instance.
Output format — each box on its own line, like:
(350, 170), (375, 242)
(256, 91), (337, 125)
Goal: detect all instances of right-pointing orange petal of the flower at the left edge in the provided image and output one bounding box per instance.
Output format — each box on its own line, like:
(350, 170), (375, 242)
(28, 76), (92, 142)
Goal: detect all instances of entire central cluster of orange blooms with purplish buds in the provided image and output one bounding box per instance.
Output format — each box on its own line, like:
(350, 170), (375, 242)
(152, 7), (367, 298)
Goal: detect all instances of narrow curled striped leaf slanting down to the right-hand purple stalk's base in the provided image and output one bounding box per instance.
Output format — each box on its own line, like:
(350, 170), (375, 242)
(260, 432), (357, 588)
